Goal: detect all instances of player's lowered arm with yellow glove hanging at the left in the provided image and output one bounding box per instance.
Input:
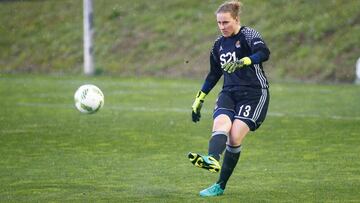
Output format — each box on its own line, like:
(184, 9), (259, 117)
(191, 52), (222, 123)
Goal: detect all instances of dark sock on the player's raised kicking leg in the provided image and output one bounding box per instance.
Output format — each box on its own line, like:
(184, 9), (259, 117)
(208, 131), (228, 161)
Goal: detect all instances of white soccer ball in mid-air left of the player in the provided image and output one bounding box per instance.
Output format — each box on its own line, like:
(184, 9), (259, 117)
(74, 84), (104, 114)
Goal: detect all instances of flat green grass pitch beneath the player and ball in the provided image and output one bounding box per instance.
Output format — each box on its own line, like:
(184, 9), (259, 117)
(0, 75), (360, 202)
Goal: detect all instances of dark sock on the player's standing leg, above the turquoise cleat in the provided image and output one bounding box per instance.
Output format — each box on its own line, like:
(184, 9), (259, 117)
(217, 145), (241, 190)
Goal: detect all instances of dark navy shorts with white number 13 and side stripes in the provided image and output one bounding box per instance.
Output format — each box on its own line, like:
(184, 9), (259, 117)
(213, 88), (270, 131)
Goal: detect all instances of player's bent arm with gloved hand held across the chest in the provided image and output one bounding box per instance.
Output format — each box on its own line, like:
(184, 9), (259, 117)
(223, 29), (270, 73)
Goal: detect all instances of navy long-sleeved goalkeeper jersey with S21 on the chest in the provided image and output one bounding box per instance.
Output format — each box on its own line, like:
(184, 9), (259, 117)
(202, 26), (270, 93)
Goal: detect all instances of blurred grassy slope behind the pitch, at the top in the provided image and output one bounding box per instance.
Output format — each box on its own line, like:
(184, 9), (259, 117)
(0, 0), (360, 83)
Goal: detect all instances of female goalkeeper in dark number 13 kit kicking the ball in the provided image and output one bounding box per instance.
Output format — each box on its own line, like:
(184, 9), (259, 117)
(188, 1), (270, 196)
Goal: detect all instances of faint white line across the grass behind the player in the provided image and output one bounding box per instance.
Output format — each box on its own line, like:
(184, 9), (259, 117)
(17, 102), (360, 120)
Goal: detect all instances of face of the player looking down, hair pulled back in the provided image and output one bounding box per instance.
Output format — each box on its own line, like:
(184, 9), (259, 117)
(216, 13), (240, 37)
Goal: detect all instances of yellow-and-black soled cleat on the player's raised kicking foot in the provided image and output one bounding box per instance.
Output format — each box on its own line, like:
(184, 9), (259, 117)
(188, 152), (221, 173)
